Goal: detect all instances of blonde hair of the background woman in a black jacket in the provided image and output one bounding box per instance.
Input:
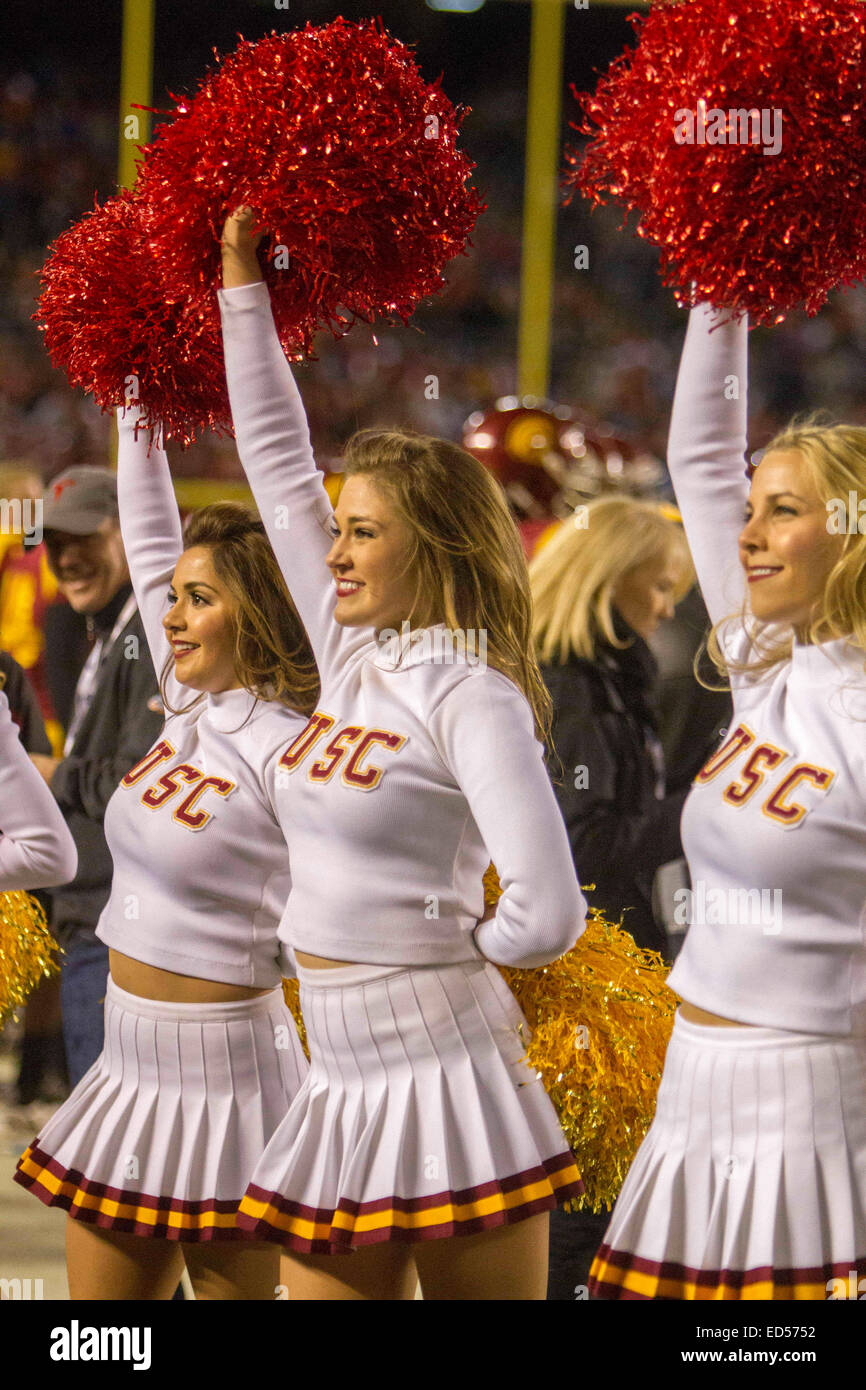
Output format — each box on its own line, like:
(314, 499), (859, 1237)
(530, 496), (695, 666)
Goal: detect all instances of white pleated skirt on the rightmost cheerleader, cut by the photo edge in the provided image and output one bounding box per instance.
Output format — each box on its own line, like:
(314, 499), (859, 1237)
(589, 1015), (866, 1300)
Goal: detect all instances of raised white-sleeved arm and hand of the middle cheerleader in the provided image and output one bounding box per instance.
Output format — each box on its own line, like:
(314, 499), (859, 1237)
(220, 218), (373, 682)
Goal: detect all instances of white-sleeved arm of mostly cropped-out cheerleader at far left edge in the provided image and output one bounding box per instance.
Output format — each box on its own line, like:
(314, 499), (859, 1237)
(0, 694), (78, 892)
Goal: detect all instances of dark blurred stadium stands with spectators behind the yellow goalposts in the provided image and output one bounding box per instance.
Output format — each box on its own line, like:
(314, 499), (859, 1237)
(0, 0), (866, 492)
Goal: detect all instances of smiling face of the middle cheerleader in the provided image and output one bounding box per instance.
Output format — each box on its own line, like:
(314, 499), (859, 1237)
(325, 474), (423, 632)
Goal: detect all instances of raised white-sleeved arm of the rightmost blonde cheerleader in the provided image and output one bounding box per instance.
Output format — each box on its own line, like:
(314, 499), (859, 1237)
(667, 304), (749, 623)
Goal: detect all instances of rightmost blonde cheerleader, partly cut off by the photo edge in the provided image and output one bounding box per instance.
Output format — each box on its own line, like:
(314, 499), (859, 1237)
(589, 298), (866, 1300)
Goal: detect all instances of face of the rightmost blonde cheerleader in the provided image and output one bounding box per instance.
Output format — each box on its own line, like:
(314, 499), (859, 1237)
(740, 449), (844, 635)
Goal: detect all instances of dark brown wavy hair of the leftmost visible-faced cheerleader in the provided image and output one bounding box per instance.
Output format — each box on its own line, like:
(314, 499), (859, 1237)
(160, 502), (320, 714)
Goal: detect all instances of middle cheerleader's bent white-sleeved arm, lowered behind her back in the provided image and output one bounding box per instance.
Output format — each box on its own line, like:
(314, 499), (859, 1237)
(428, 670), (587, 969)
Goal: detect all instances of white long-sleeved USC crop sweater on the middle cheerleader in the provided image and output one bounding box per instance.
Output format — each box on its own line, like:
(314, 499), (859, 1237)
(220, 285), (585, 966)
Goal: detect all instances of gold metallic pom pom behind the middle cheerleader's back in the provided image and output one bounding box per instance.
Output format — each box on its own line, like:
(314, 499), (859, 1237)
(484, 865), (678, 1212)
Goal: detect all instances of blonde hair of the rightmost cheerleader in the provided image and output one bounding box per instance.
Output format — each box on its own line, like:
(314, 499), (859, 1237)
(702, 413), (866, 685)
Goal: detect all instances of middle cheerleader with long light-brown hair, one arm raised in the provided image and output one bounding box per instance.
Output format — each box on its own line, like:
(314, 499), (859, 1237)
(220, 210), (585, 1298)
